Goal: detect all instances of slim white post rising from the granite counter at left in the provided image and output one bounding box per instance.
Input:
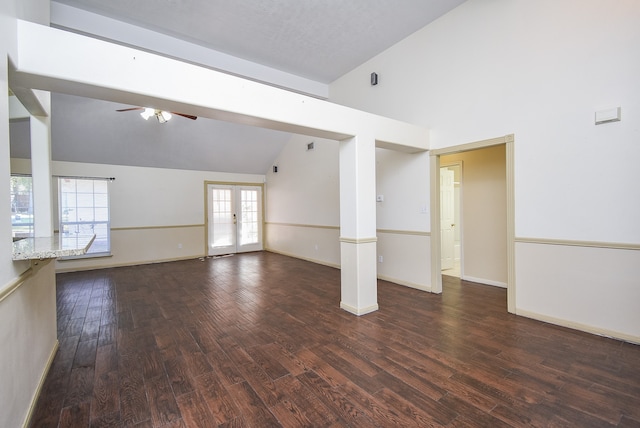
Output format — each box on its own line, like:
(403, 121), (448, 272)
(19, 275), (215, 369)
(30, 102), (53, 237)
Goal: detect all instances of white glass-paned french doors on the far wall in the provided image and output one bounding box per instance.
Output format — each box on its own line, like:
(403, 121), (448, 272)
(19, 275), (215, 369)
(207, 184), (262, 256)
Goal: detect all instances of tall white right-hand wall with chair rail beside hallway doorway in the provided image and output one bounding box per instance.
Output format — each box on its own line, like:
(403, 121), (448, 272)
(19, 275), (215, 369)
(330, 0), (640, 341)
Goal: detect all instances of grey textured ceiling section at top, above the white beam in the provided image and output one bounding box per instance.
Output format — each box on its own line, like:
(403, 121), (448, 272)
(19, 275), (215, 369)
(56, 0), (464, 83)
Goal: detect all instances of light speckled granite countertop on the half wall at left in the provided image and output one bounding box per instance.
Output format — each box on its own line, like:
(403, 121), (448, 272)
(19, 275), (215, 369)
(13, 233), (96, 260)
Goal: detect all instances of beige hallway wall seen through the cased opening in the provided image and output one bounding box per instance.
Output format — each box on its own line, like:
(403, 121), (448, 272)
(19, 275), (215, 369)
(440, 145), (507, 287)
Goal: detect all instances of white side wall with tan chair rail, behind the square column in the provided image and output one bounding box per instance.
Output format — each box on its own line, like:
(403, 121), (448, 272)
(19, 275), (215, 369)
(266, 135), (431, 290)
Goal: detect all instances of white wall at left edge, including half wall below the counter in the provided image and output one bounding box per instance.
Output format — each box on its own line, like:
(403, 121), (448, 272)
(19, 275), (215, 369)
(0, 0), (57, 427)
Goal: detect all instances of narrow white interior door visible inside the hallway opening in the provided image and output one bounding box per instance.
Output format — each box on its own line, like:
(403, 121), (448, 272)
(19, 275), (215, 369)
(440, 167), (455, 270)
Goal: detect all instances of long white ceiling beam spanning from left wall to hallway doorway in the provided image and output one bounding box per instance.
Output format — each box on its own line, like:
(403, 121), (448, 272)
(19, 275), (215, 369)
(10, 21), (429, 152)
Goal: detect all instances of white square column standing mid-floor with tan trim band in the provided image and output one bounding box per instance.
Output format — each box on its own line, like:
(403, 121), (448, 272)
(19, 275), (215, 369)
(340, 134), (378, 315)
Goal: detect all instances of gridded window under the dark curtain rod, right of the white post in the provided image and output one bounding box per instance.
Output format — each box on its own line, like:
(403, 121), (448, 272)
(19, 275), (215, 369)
(58, 177), (111, 257)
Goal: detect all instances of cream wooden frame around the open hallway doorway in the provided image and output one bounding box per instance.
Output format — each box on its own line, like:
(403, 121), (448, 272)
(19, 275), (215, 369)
(429, 134), (516, 313)
